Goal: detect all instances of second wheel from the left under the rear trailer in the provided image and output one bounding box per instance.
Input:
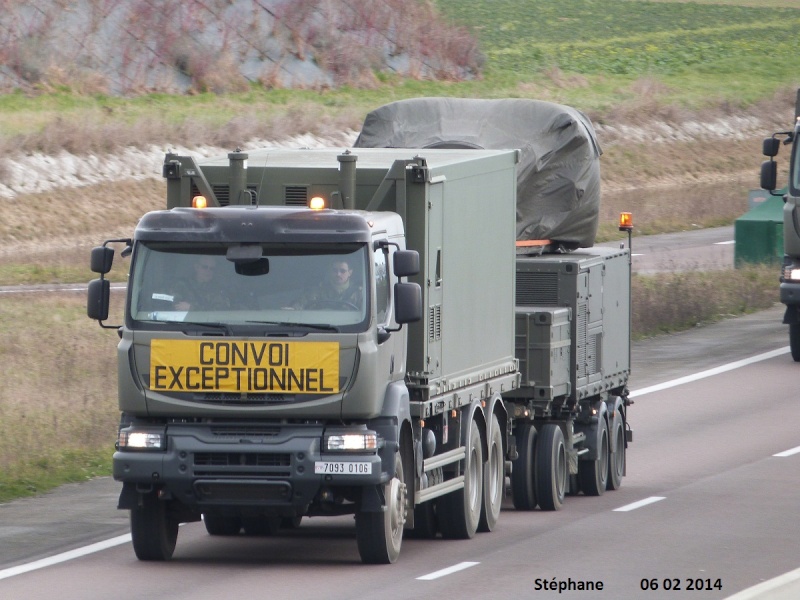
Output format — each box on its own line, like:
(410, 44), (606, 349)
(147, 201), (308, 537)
(534, 423), (567, 510)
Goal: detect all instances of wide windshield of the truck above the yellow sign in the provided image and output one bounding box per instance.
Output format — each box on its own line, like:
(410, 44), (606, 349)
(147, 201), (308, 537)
(130, 242), (369, 331)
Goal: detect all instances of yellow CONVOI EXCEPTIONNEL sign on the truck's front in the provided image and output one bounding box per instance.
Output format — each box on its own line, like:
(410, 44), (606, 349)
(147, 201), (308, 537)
(150, 340), (339, 394)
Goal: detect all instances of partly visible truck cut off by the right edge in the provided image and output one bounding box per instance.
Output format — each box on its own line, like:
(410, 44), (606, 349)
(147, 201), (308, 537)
(761, 89), (800, 362)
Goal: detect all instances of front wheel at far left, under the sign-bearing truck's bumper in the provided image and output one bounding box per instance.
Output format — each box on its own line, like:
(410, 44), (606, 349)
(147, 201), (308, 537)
(131, 494), (178, 561)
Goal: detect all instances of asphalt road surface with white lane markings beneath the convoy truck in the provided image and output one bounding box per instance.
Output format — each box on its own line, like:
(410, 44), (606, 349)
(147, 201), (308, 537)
(0, 226), (800, 600)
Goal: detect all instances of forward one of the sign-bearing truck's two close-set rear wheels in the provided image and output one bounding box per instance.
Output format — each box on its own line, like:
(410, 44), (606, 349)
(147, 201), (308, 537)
(437, 421), (483, 540)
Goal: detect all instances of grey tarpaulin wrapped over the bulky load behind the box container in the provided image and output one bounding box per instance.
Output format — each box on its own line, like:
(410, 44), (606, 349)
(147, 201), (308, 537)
(355, 98), (601, 248)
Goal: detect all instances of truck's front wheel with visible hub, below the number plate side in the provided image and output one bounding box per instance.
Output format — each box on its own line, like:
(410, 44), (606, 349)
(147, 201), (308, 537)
(356, 452), (406, 565)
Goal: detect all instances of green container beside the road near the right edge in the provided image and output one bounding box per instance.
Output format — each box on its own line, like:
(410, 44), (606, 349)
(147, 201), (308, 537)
(733, 196), (783, 267)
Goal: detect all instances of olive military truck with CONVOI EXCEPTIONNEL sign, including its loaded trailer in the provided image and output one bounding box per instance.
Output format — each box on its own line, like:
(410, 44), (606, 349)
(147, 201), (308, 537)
(87, 99), (632, 563)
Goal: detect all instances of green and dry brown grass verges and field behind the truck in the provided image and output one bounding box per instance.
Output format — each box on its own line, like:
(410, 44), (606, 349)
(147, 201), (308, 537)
(0, 0), (800, 501)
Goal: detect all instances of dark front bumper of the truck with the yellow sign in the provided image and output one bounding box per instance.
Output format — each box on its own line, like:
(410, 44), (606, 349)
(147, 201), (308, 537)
(113, 425), (395, 510)
